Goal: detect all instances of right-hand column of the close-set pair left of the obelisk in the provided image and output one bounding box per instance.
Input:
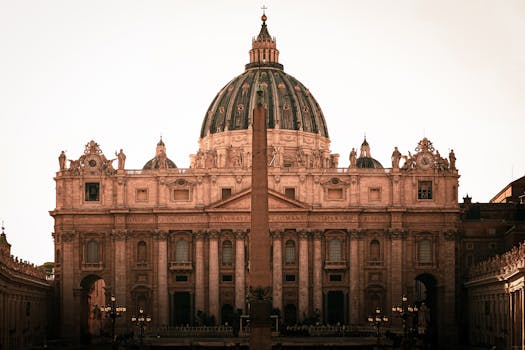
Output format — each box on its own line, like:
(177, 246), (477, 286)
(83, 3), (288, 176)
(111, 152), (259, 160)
(208, 230), (220, 322)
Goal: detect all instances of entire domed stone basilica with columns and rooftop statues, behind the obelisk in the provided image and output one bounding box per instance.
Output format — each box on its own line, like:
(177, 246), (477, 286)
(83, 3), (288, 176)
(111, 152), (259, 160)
(50, 16), (461, 341)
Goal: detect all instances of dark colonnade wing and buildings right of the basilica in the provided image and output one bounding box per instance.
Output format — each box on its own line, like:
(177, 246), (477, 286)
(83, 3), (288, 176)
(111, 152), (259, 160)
(458, 177), (525, 349)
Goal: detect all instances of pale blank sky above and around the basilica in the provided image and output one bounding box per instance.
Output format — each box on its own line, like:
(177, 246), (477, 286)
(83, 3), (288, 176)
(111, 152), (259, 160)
(0, 0), (525, 264)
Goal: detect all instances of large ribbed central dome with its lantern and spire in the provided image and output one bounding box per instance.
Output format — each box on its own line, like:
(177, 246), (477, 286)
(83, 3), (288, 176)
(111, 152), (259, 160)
(200, 16), (328, 138)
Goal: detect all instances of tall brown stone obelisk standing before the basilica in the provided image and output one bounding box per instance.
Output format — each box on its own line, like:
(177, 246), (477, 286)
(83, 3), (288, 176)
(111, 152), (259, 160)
(248, 84), (272, 350)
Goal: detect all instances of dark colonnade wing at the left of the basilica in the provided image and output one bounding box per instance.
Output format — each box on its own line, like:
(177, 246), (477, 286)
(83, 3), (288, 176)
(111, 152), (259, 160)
(0, 227), (53, 349)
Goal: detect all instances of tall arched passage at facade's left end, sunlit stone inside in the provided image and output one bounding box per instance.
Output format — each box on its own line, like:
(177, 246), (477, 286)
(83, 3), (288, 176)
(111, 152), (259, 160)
(80, 275), (106, 343)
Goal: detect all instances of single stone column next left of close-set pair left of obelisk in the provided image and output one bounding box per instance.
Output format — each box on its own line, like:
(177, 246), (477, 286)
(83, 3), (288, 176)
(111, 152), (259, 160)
(156, 230), (169, 326)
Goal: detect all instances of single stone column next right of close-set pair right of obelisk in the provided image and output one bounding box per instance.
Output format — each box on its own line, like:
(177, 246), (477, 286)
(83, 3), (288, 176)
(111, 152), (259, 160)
(348, 230), (360, 324)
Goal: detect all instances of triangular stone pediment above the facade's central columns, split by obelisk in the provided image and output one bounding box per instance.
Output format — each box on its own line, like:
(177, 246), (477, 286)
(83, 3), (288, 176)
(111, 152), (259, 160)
(208, 189), (309, 210)
